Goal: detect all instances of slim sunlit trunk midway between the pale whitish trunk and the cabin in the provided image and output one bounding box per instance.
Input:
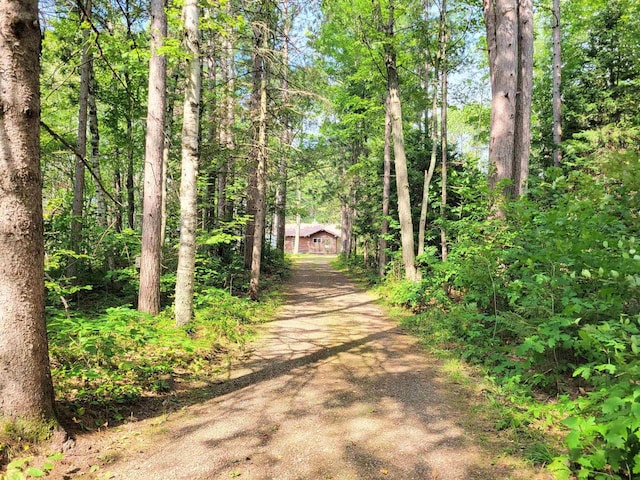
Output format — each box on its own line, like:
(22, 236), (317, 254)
(249, 1), (270, 300)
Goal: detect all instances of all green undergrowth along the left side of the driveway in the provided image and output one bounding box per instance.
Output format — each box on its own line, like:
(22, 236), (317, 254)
(0, 248), (288, 480)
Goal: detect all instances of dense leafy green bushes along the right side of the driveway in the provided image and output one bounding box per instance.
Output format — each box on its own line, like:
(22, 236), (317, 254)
(338, 151), (640, 479)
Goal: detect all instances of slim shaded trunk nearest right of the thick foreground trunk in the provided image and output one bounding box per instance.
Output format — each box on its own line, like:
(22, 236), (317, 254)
(68, 0), (91, 268)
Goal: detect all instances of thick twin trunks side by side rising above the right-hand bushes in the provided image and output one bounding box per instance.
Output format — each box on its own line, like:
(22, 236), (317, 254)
(484, 0), (533, 204)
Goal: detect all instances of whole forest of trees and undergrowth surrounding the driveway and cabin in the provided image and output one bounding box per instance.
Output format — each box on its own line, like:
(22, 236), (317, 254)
(0, 0), (640, 479)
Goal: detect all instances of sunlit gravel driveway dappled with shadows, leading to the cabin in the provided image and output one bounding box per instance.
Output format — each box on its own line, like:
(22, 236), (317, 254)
(58, 257), (526, 480)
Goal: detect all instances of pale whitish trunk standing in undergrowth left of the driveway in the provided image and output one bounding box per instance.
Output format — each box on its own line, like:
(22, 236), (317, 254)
(175, 0), (201, 325)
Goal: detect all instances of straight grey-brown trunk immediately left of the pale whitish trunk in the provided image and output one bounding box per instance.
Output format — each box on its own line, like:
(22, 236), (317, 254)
(138, 0), (167, 315)
